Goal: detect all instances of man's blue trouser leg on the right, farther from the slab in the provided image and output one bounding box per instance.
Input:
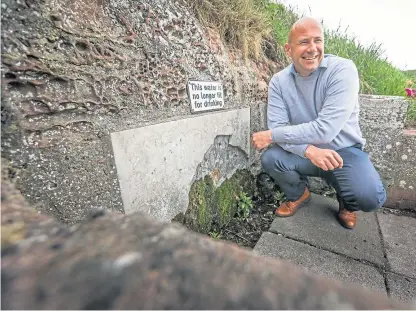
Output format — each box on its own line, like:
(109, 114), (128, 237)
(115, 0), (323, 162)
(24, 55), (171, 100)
(323, 147), (386, 212)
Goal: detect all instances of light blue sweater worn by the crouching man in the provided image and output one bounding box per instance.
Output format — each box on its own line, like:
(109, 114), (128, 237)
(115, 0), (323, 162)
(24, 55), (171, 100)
(267, 54), (365, 157)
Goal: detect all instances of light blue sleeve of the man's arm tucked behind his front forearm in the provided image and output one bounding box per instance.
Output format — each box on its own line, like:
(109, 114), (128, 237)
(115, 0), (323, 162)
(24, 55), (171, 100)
(267, 76), (308, 157)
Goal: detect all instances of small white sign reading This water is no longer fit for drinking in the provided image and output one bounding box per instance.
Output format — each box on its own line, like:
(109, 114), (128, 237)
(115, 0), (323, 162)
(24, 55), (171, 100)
(188, 81), (224, 112)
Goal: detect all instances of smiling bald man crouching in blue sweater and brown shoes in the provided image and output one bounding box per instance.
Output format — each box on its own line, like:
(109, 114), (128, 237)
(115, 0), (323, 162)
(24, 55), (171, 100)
(252, 17), (386, 229)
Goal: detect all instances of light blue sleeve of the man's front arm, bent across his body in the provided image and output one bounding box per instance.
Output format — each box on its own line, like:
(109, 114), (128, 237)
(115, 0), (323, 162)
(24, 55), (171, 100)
(272, 61), (360, 145)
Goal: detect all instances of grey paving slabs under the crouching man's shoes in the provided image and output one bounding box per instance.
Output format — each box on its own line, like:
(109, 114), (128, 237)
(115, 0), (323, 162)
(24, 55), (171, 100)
(253, 194), (416, 303)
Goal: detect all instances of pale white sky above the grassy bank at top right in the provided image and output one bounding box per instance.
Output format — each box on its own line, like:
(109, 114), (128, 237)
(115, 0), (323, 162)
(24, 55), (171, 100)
(278, 0), (416, 70)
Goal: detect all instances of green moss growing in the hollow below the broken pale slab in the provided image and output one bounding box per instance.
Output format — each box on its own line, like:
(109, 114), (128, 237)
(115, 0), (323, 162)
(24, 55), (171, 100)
(183, 170), (254, 233)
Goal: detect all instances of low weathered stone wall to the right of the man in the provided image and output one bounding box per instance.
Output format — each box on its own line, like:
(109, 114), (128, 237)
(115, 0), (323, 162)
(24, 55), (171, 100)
(304, 95), (416, 210)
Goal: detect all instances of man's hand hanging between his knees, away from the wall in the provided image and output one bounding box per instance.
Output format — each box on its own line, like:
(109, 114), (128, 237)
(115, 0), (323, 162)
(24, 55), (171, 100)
(305, 145), (344, 171)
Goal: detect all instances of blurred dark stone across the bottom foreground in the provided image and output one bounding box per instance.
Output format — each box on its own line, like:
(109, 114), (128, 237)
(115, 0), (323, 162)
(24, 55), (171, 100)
(1, 184), (411, 309)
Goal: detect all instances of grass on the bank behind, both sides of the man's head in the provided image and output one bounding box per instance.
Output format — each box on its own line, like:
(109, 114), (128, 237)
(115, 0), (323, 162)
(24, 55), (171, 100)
(184, 0), (416, 122)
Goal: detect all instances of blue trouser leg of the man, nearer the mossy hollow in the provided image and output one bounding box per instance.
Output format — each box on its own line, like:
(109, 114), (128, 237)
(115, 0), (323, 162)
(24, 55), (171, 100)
(261, 145), (319, 201)
